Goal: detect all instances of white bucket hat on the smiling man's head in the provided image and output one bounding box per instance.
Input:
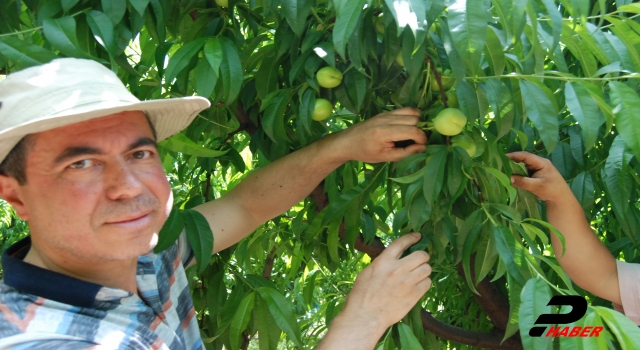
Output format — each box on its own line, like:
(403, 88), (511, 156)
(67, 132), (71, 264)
(0, 58), (211, 163)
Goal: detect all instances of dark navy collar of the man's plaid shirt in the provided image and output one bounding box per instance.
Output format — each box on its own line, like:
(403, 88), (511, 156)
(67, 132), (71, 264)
(2, 236), (121, 307)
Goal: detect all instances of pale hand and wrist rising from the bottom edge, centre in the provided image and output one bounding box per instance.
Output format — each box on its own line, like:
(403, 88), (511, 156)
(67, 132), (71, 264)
(318, 233), (431, 350)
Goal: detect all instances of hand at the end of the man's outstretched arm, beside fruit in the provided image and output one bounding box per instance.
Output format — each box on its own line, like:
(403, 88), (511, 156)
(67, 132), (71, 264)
(331, 108), (427, 163)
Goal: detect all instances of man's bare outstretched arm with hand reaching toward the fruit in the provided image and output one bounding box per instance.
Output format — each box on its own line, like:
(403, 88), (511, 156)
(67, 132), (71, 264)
(194, 108), (427, 253)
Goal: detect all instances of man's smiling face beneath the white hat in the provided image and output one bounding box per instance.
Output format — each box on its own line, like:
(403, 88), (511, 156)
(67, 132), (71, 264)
(14, 112), (173, 261)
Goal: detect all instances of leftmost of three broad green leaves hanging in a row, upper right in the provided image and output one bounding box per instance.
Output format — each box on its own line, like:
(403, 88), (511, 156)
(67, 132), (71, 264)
(520, 80), (559, 153)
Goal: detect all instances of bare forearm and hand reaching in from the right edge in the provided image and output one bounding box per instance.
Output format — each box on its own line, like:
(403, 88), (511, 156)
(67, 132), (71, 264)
(507, 152), (622, 304)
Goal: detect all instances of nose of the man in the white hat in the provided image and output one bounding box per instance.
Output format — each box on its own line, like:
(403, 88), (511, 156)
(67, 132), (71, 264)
(105, 160), (144, 200)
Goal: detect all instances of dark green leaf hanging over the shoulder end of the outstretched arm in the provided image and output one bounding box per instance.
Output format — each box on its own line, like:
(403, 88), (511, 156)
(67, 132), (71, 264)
(182, 209), (213, 274)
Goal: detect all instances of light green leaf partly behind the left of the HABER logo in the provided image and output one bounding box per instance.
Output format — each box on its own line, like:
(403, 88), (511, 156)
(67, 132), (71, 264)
(518, 278), (553, 350)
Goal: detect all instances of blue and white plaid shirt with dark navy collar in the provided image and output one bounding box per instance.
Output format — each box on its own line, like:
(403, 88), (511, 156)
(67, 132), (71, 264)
(0, 231), (204, 350)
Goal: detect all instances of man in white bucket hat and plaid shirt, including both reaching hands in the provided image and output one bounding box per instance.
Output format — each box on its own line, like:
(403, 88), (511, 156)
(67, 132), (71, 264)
(0, 58), (431, 349)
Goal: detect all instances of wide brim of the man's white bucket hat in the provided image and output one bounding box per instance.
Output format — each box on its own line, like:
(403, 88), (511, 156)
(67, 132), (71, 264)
(0, 96), (211, 162)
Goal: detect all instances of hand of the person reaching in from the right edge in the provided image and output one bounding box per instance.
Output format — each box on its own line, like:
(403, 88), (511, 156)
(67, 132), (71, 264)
(507, 152), (573, 202)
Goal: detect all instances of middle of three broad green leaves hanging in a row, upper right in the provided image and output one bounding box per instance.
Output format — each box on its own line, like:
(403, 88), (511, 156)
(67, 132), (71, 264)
(564, 82), (604, 152)
